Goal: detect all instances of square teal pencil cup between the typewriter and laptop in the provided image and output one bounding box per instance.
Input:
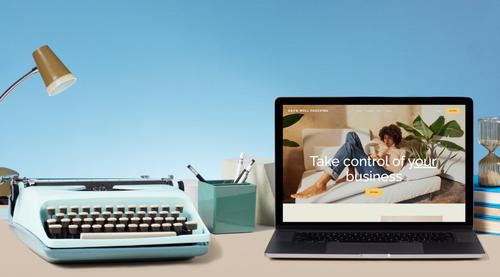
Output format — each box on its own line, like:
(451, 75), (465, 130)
(198, 180), (256, 234)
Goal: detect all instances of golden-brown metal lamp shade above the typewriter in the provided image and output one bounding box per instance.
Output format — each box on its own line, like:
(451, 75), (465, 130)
(33, 45), (76, 96)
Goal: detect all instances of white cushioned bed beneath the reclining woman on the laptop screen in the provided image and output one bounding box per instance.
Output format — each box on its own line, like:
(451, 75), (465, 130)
(295, 129), (441, 203)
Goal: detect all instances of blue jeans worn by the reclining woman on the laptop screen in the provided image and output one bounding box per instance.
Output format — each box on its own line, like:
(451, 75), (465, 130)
(327, 132), (392, 180)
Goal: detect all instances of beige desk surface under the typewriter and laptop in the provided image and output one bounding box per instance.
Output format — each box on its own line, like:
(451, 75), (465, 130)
(0, 220), (500, 277)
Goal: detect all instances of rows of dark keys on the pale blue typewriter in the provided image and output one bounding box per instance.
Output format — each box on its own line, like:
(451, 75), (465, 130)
(42, 205), (198, 239)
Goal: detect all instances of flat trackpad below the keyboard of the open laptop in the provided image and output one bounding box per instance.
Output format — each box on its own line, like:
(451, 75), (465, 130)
(326, 242), (424, 254)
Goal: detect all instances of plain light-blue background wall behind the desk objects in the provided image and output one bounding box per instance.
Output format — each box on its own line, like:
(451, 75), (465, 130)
(0, 0), (500, 178)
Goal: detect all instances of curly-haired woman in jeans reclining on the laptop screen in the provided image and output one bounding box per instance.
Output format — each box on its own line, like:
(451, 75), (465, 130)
(291, 124), (405, 198)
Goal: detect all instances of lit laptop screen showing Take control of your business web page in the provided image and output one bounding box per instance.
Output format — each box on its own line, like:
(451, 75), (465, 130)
(282, 104), (466, 222)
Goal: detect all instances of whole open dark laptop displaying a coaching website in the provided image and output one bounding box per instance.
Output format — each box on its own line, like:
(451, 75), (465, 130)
(265, 97), (485, 259)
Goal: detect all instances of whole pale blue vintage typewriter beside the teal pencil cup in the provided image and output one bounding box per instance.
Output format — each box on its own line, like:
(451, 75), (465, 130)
(8, 176), (210, 263)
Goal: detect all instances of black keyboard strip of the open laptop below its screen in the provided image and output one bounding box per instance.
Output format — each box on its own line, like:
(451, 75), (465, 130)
(294, 232), (454, 243)
